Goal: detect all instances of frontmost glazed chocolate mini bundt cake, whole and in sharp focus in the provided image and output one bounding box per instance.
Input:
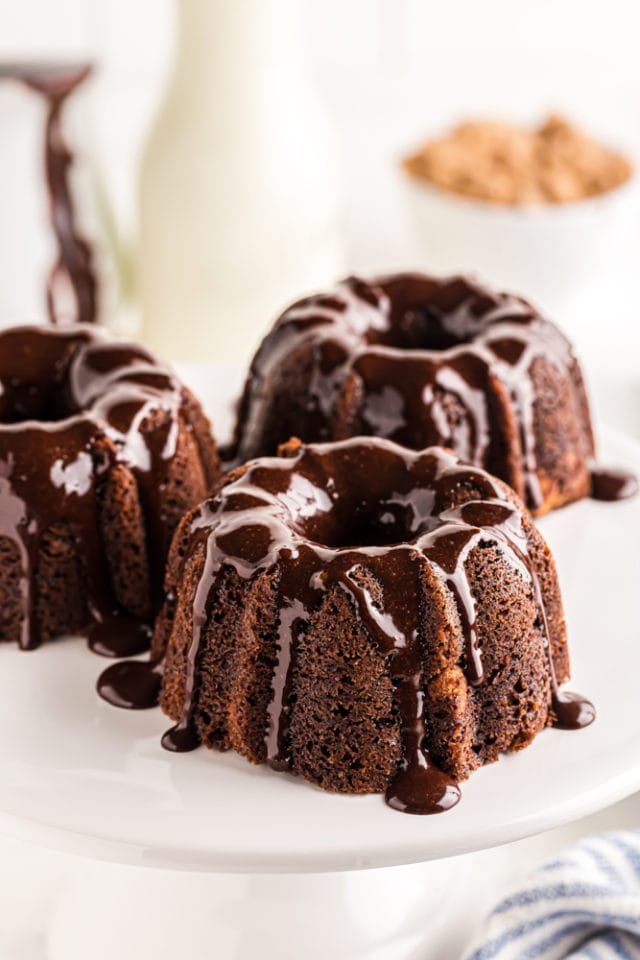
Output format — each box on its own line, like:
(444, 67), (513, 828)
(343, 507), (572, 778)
(152, 437), (594, 813)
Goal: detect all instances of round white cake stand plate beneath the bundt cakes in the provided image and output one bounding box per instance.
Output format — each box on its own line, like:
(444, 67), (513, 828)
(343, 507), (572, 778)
(0, 416), (640, 871)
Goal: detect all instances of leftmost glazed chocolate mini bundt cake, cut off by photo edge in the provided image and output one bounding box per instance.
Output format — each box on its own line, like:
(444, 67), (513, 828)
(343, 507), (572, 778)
(0, 325), (219, 654)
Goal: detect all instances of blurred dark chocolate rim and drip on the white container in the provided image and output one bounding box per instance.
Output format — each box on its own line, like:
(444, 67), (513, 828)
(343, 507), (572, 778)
(0, 63), (97, 323)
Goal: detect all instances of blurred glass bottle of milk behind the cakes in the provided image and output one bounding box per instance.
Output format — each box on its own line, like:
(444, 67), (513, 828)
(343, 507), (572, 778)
(140, 0), (343, 362)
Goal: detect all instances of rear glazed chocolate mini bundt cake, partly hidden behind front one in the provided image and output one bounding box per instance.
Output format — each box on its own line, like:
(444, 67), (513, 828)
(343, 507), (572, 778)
(231, 273), (594, 514)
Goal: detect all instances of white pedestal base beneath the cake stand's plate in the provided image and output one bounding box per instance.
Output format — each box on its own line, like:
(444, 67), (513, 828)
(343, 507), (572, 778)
(47, 858), (468, 960)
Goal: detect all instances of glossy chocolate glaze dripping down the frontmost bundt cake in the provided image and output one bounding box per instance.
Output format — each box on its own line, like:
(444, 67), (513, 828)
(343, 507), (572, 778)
(163, 438), (594, 813)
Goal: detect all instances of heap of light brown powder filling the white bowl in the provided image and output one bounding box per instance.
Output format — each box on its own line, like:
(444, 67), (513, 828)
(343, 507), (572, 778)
(403, 115), (632, 205)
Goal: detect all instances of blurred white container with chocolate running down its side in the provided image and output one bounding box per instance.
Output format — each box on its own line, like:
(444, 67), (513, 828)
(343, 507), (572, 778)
(0, 61), (98, 323)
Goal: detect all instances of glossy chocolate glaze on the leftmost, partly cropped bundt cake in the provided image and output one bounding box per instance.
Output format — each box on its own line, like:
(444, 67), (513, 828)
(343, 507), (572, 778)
(0, 326), (182, 656)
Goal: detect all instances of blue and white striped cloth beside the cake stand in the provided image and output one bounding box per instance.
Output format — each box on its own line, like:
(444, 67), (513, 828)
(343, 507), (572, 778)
(465, 831), (640, 960)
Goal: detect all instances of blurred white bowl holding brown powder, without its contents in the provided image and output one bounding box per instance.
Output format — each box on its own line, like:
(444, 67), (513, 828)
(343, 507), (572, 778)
(404, 174), (640, 310)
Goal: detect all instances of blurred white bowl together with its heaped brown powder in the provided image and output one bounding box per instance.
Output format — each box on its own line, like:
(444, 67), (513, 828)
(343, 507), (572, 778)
(402, 115), (640, 308)
